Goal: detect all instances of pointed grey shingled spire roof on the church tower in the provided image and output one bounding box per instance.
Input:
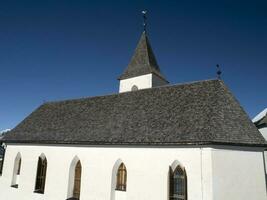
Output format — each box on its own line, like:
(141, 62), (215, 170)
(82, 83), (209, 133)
(118, 31), (168, 82)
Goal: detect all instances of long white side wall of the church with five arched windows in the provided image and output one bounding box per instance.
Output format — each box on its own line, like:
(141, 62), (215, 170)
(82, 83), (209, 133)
(0, 145), (208, 200)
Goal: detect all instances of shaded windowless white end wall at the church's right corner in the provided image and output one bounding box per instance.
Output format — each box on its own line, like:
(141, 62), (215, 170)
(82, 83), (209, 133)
(212, 149), (267, 200)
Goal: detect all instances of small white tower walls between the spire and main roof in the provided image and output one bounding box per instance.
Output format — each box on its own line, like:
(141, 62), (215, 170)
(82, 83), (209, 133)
(119, 74), (167, 92)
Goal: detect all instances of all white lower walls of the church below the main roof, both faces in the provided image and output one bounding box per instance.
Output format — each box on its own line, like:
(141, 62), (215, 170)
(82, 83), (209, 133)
(0, 145), (266, 200)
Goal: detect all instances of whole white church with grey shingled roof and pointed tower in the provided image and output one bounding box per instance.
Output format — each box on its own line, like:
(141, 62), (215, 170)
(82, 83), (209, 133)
(0, 29), (267, 200)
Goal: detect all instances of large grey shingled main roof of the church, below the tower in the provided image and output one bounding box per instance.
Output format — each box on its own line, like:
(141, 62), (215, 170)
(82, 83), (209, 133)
(4, 80), (266, 145)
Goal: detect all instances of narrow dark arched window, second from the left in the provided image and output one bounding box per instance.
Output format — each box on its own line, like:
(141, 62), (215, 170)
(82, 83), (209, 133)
(34, 156), (47, 194)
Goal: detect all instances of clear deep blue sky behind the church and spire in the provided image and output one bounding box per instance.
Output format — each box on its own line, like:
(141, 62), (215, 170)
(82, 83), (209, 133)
(0, 0), (267, 130)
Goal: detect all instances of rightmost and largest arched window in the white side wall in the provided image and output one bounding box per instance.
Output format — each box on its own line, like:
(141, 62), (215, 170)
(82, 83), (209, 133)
(169, 165), (187, 200)
